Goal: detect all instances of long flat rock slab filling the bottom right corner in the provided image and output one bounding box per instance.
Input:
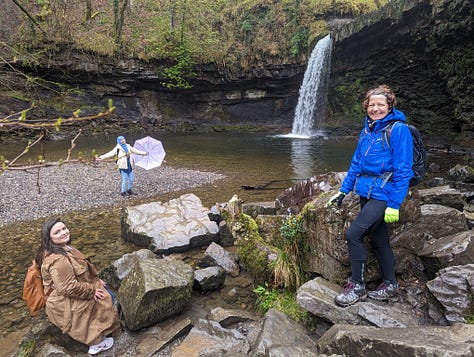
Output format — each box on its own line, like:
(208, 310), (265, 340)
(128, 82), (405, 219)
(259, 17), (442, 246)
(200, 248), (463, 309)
(318, 324), (474, 357)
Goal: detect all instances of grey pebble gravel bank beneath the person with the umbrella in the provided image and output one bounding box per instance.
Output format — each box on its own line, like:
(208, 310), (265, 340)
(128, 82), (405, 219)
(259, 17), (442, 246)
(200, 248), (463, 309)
(0, 162), (225, 226)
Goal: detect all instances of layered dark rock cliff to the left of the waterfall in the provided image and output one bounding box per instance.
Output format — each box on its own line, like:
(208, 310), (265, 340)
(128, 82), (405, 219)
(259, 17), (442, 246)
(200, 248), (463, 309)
(16, 51), (306, 130)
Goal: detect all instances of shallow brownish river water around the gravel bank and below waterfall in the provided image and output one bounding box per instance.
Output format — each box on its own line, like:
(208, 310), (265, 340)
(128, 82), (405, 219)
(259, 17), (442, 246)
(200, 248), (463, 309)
(0, 129), (458, 350)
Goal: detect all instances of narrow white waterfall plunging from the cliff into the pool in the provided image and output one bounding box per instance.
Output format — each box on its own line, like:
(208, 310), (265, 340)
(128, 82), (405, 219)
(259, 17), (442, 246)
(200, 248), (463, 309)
(291, 35), (332, 137)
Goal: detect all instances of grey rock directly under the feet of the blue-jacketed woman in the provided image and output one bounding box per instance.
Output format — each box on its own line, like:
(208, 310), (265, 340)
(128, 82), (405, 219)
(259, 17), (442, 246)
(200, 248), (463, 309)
(296, 277), (418, 327)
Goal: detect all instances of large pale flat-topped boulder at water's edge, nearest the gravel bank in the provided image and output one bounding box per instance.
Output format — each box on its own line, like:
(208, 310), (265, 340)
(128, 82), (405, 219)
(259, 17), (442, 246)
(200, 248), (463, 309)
(121, 194), (219, 254)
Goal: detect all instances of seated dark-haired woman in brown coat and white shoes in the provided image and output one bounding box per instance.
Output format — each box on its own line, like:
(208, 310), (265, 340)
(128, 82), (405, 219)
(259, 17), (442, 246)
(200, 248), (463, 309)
(35, 218), (120, 355)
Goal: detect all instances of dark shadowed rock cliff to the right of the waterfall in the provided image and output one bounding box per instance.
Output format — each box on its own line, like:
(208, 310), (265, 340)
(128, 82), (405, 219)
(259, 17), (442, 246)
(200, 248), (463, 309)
(329, 0), (474, 143)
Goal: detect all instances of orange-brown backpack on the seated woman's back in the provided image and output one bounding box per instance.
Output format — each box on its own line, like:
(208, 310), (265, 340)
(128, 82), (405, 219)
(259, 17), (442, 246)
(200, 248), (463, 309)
(23, 260), (53, 316)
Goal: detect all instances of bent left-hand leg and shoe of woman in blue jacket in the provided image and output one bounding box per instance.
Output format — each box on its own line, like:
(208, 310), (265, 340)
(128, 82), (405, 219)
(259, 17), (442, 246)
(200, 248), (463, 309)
(336, 197), (386, 306)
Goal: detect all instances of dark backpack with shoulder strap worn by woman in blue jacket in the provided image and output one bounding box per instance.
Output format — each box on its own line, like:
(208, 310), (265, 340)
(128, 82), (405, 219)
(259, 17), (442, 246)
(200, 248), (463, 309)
(383, 120), (426, 187)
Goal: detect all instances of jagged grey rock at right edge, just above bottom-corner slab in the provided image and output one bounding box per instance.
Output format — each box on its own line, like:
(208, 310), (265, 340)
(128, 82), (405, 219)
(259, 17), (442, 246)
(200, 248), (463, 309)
(426, 264), (474, 322)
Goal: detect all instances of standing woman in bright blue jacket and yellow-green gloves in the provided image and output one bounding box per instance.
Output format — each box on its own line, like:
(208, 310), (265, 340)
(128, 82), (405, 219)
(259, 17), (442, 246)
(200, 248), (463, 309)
(327, 85), (413, 307)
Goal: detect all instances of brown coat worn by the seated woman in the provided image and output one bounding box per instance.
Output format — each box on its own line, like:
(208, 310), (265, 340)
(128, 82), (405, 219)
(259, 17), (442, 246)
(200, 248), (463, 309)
(41, 247), (120, 345)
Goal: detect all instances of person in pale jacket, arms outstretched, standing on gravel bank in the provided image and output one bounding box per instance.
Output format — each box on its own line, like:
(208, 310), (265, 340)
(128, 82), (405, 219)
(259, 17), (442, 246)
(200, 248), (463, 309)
(97, 135), (148, 196)
